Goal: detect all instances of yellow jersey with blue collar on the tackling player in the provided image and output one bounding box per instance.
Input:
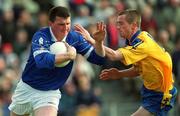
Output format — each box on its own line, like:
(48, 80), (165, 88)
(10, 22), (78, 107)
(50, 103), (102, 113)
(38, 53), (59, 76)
(118, 31), (173, 93)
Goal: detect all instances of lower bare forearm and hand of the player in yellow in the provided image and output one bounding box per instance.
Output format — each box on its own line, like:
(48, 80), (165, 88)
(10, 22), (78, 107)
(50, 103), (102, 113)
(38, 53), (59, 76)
(100, 67), (139, 80)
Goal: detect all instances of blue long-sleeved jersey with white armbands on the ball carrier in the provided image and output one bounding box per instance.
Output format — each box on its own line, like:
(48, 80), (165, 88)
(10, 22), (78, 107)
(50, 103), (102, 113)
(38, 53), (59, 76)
(22, 27), (105, 91)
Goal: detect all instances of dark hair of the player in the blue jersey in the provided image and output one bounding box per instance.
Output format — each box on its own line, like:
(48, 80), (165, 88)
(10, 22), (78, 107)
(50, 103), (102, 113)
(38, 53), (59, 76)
(49, 6), (70, 22)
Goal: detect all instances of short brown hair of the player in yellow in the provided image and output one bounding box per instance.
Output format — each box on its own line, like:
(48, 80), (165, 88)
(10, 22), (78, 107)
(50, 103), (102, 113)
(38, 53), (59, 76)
(118, 9), (141, 28)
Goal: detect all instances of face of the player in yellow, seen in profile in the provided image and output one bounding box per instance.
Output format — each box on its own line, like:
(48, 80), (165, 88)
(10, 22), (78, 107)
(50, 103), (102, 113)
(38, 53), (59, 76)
(116, 15), (132, 39)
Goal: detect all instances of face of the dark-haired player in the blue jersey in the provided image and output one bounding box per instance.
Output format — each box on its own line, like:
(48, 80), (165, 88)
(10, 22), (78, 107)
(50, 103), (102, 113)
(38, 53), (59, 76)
(50, 17), (71, 37)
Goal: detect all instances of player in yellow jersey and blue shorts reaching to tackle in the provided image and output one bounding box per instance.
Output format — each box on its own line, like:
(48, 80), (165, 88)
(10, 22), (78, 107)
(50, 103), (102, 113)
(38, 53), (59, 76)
(75, 10), (177, 116)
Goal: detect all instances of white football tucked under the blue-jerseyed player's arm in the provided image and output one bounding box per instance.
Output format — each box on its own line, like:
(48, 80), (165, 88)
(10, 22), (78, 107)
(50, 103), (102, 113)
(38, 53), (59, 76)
(50, 42), (70, 67)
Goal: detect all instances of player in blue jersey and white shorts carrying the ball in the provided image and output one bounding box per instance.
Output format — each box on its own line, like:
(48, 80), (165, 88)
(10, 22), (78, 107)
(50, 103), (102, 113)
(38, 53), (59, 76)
(9, 6), (105, 116)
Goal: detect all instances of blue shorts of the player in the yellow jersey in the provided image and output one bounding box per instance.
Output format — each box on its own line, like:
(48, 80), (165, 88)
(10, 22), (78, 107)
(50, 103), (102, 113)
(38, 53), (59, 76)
(141, 86), (177, 116)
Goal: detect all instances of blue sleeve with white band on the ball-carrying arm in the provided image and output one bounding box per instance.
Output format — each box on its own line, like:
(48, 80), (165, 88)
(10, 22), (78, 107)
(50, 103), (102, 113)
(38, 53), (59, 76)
(32, 33), (55, 68)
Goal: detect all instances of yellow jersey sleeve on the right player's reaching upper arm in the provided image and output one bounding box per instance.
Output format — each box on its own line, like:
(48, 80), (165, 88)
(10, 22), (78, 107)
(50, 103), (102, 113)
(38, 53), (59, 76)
(118, 43), (148, 65)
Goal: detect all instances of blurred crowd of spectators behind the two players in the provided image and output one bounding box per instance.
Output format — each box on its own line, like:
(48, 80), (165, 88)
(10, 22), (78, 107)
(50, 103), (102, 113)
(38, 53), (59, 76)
(0, 0), (180, 116)
